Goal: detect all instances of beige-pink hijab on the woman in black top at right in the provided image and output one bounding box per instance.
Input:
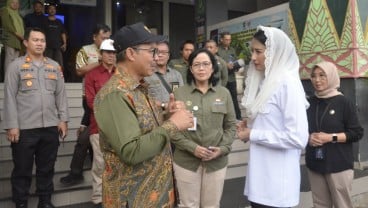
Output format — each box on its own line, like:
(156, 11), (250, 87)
(312, 61), (342, 98)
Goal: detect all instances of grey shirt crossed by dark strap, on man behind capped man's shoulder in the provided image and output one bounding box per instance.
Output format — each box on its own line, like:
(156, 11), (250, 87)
(144, 67), (184, 103)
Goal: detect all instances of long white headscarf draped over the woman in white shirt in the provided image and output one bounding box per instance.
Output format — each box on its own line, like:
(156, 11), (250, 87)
(242, 26), (309, 121)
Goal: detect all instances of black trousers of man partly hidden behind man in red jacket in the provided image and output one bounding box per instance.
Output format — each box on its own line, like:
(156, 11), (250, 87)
(70, 97), (93, 175)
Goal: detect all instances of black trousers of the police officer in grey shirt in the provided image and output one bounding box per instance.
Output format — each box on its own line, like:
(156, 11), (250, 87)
(11, 126), (59, 203)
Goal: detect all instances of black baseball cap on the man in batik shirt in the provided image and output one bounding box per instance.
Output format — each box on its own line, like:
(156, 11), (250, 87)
(112, 22), (166, 53)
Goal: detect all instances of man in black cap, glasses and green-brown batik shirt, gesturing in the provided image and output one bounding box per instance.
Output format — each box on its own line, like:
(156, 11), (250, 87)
(94, 23), (193, 208)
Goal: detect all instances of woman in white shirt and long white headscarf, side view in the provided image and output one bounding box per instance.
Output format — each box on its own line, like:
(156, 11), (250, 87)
(237, 26), (309, 208)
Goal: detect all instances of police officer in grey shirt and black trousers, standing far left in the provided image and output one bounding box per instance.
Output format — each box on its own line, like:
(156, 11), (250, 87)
(3, 28), (69, 208)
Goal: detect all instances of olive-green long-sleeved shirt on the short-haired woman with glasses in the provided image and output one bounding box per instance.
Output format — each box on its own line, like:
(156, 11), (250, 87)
(172, 84), (236, 172)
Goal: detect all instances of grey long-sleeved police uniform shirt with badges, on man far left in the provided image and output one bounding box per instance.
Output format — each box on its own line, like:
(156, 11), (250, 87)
(3, 56), (69, 129)
